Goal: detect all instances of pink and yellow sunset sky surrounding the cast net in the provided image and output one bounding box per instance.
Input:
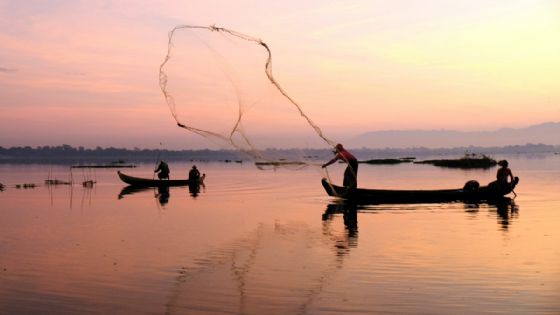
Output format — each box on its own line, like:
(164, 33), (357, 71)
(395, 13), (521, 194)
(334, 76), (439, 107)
(0, 0), (560, 149)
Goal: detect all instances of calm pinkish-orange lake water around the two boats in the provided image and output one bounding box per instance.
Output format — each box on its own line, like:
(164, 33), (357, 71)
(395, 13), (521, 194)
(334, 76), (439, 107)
(0, 155), (560, 314)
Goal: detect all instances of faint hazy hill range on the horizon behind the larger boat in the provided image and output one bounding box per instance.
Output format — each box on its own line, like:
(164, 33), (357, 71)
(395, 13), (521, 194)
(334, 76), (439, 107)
(346, 122), (560, 148)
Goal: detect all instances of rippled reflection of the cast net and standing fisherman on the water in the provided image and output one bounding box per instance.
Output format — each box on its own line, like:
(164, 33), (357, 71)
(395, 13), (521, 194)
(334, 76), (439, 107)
(165, 204), (364, 314)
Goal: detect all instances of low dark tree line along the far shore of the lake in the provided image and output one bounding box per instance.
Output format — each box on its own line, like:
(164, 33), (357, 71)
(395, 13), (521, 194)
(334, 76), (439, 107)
(0, 143), (560, 164)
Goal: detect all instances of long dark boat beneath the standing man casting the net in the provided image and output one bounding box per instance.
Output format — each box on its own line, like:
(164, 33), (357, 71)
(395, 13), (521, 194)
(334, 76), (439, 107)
(321, 177), (519, 204)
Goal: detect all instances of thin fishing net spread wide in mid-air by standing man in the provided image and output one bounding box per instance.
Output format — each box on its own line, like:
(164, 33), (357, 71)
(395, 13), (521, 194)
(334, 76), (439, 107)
(159, 25), (336, 165)
